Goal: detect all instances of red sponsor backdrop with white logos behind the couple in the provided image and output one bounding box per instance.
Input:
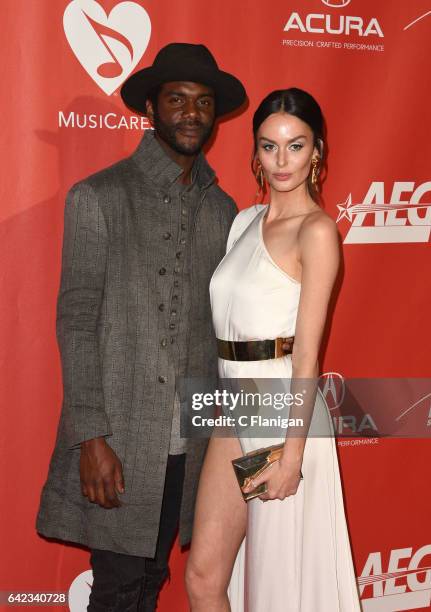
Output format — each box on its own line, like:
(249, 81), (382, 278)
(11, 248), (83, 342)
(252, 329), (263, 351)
(0, 0), (431, 612)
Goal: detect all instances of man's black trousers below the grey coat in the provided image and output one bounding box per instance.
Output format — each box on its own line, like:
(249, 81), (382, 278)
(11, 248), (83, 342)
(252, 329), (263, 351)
(87, 454), (185, 612)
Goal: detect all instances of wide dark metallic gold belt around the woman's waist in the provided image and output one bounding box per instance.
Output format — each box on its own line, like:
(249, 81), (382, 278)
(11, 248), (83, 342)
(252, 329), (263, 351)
(217, 336), (295, 361)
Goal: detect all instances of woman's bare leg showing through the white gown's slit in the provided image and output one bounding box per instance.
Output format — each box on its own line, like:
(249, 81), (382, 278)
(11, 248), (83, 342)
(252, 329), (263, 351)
(186, 437), (247, 612)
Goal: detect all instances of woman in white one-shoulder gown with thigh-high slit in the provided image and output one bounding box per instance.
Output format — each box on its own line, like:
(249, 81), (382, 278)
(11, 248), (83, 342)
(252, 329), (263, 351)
(186, 88), (361, 612)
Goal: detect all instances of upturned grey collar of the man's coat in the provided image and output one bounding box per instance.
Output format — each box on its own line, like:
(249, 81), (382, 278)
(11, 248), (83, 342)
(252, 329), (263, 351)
(133, 129), (215, 189)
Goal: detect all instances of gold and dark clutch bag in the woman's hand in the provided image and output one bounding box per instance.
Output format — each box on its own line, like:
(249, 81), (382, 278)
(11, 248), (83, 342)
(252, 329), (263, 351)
(232, 442), (302, 501)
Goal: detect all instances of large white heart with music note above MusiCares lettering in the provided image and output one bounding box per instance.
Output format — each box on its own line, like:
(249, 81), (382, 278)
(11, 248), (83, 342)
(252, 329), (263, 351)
(63, 0), (151, 96)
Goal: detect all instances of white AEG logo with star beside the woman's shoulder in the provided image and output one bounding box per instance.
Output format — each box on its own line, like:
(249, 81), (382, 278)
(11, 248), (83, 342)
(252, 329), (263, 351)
(337, 181), (431, 244)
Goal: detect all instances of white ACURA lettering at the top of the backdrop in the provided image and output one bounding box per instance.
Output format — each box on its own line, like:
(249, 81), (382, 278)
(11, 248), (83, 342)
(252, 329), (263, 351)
(284, 0), (384, 38)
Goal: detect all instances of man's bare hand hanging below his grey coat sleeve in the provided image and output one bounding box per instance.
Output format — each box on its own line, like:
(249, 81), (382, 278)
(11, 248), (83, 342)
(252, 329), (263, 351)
(79, 438), (124, 508)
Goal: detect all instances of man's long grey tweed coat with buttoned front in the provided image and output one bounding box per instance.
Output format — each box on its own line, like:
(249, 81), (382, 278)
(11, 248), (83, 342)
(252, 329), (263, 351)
(37, 131), (237, 557)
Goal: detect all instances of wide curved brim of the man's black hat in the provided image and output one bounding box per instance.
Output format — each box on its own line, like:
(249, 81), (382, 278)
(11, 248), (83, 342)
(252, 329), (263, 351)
(120, 66), (246, 117)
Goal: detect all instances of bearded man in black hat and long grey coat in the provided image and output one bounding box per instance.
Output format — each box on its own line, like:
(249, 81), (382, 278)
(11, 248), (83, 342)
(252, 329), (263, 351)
(37, 43), (245, 612)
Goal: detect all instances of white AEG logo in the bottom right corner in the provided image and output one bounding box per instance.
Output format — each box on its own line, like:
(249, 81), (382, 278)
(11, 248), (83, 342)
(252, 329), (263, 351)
(358, 544), (431, 612)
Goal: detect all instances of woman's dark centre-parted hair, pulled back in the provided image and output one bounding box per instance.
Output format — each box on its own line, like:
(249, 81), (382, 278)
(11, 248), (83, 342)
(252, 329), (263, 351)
(252, 87), (326, 201)
